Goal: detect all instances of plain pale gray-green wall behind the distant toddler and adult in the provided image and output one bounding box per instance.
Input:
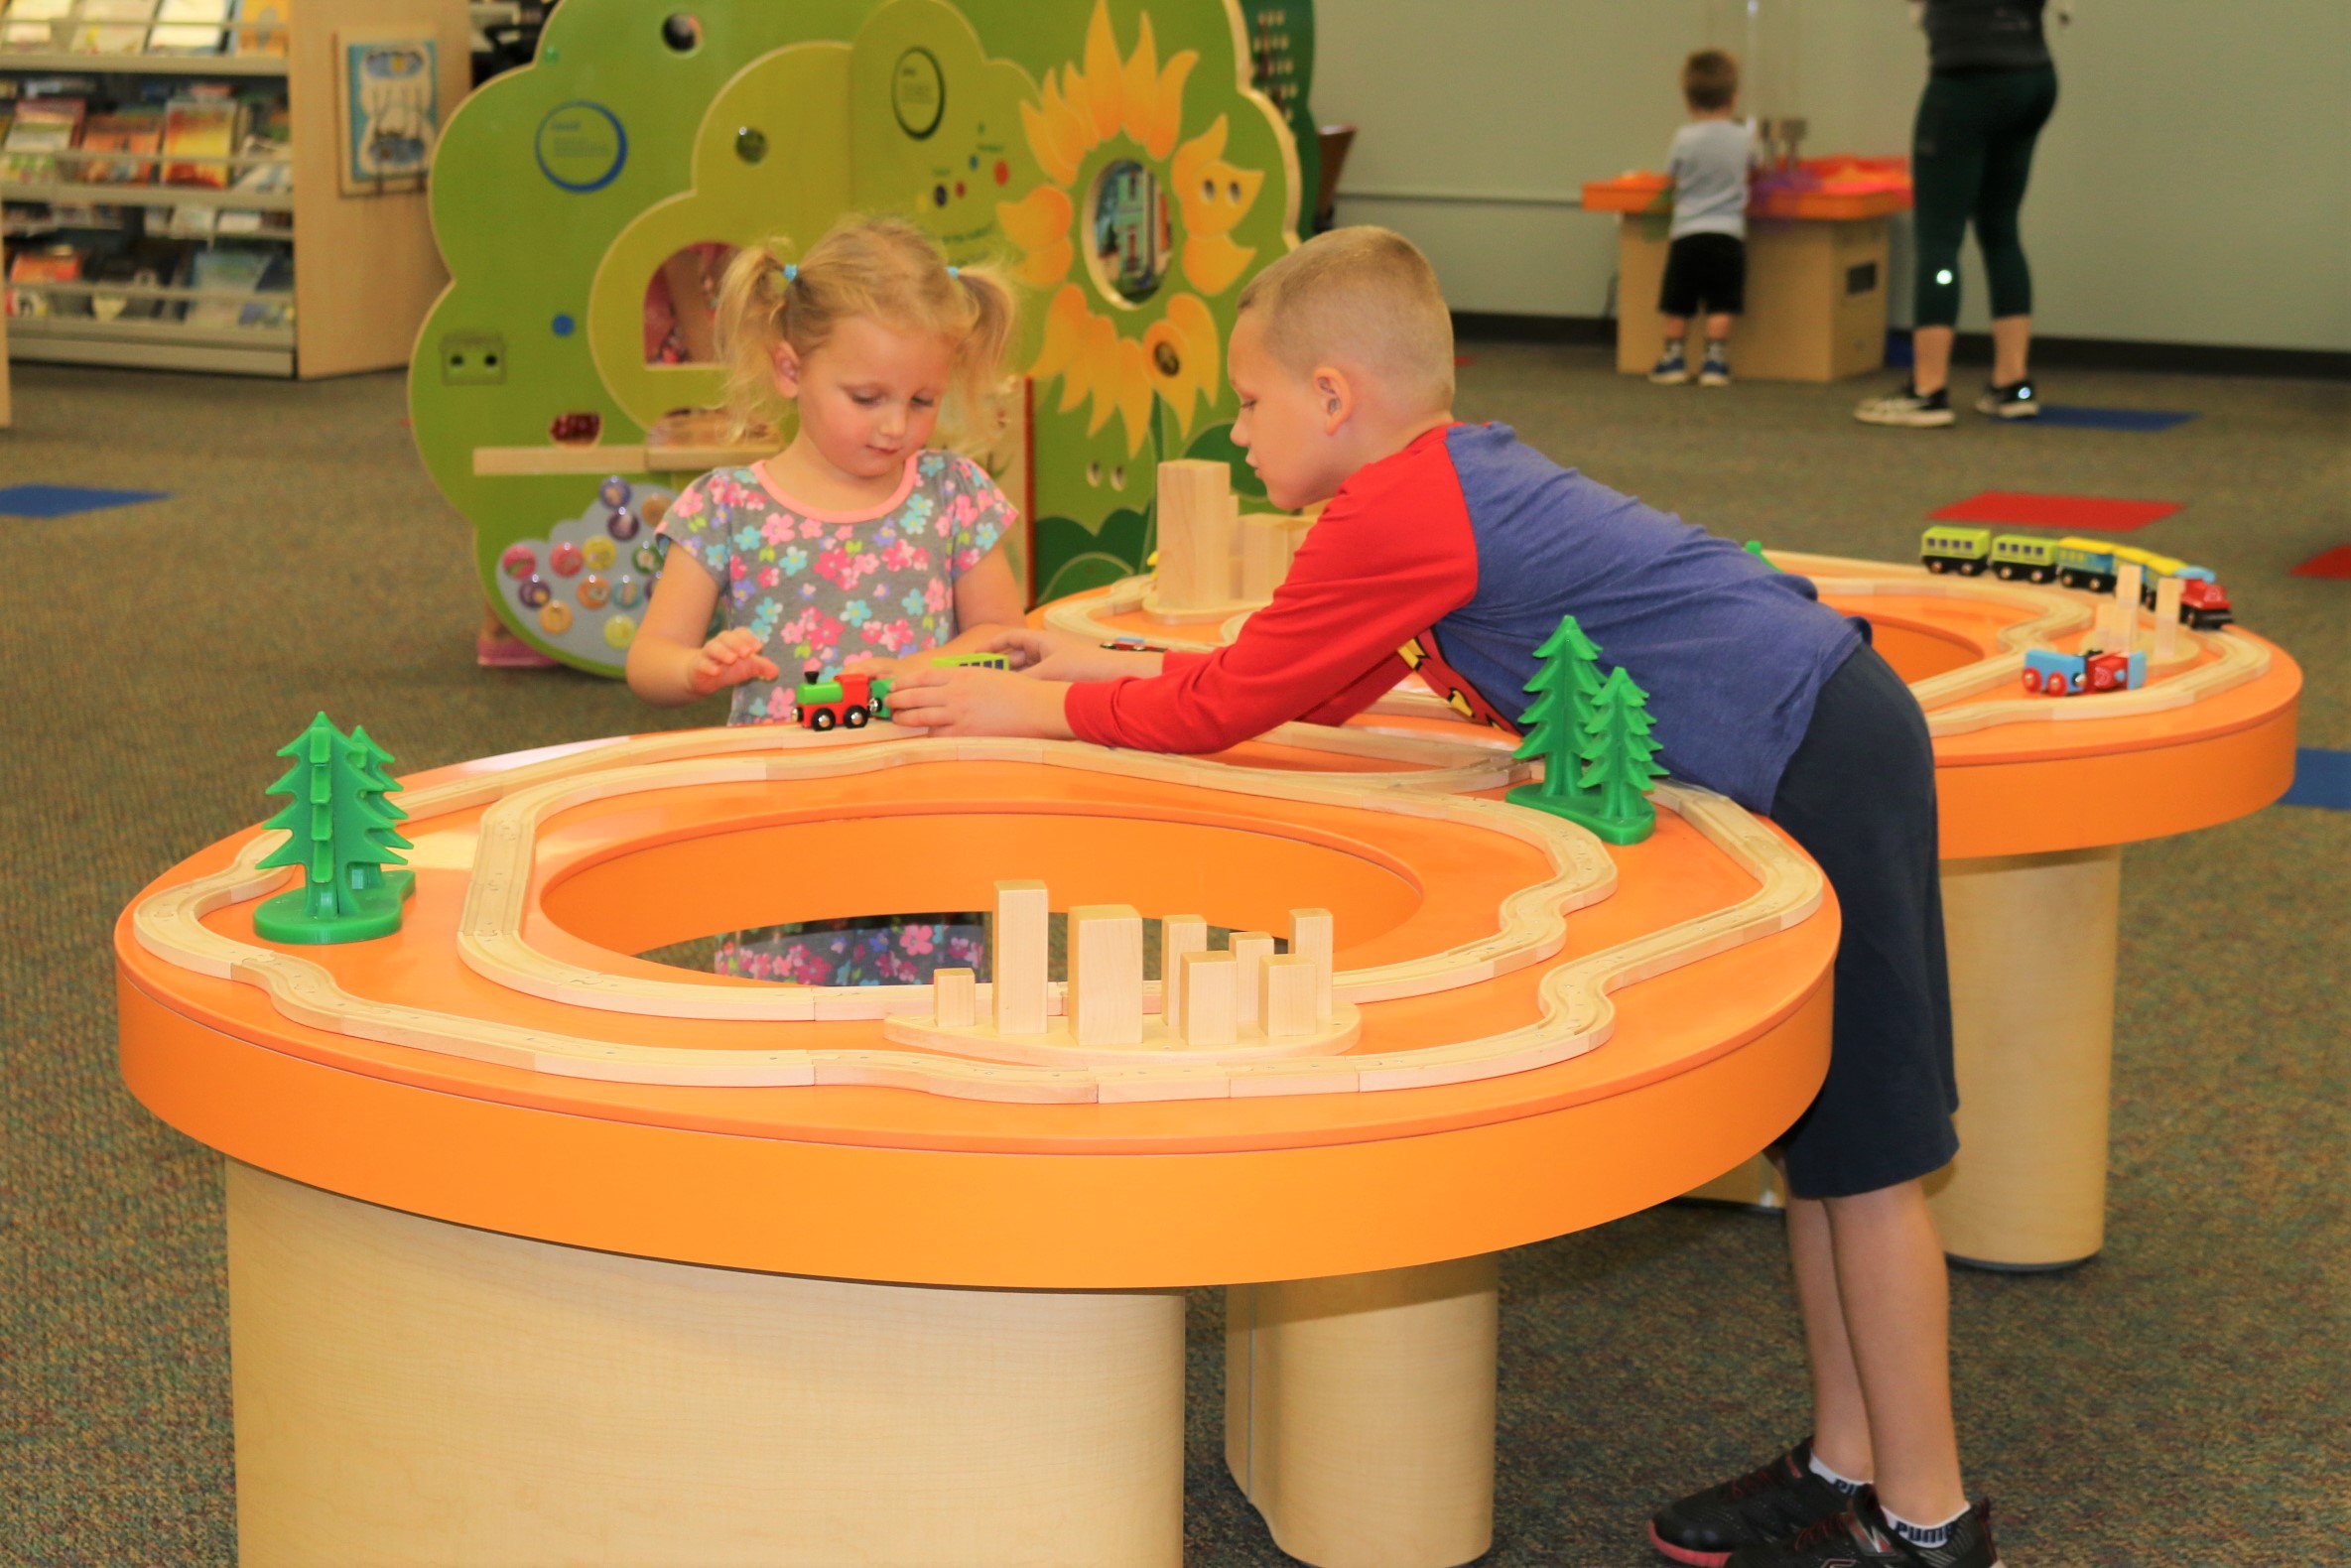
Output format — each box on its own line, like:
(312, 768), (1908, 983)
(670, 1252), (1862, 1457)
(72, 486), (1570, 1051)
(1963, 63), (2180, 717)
(1314, 0), (2351, 350)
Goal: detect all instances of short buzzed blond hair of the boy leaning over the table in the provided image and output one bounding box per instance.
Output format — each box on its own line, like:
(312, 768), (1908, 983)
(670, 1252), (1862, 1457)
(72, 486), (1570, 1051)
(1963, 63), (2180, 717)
(1239, 225), (1453, 414)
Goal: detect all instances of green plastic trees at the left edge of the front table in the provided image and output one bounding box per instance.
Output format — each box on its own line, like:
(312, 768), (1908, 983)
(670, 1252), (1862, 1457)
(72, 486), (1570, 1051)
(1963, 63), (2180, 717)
(254, 715), (416, 945)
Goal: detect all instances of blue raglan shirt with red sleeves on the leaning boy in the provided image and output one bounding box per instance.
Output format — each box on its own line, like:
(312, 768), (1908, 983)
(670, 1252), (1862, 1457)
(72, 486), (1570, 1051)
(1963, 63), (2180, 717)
(1068, 426), (1862, 811)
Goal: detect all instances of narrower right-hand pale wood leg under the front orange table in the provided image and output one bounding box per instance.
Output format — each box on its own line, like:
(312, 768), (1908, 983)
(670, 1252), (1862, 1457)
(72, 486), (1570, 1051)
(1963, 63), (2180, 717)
(1225, 1253), (1498, 1568)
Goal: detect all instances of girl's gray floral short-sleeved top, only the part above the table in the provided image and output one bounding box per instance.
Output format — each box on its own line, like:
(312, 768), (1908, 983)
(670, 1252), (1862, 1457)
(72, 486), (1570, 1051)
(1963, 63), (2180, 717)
(661, 452), (1018, 724)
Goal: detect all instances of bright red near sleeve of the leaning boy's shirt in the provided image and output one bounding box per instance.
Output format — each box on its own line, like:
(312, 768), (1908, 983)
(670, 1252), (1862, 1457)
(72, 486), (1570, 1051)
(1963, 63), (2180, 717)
(1065, 445), (1477, 752)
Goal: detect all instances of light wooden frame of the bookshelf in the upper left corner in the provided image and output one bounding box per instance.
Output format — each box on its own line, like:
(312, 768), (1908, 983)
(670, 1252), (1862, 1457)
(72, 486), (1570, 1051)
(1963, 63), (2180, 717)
(0, 0), (472, 378)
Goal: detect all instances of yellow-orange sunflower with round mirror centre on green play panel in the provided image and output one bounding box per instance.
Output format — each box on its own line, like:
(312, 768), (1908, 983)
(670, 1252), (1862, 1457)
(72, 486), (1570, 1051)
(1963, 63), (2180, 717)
(996, 0), (1265, 454)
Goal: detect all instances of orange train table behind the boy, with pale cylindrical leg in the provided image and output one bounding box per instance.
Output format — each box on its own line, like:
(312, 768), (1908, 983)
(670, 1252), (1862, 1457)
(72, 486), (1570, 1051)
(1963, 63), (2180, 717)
(1034, 550), (2301, 1269)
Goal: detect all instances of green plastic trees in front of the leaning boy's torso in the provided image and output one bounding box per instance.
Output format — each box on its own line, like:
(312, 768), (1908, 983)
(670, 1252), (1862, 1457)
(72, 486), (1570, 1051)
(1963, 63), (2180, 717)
(1509, 616), (1664, 844)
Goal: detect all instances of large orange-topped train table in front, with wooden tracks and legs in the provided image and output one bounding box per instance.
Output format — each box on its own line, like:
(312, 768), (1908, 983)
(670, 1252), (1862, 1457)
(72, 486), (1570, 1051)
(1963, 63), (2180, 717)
(115, 724), (1836, 1568)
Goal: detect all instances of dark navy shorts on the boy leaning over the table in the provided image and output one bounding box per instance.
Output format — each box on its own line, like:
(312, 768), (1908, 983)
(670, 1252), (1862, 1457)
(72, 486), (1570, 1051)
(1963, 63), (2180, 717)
(1770, 646), (1958, 1199)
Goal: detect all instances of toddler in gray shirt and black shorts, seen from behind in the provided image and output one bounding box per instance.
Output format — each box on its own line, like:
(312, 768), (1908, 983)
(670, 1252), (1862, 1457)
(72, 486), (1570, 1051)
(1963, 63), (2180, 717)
(1648, 50), (1754, 385)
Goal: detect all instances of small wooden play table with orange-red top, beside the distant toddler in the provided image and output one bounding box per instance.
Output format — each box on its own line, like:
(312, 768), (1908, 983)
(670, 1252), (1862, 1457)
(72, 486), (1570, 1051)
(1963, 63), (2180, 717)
(1585, 177), (1909, 381)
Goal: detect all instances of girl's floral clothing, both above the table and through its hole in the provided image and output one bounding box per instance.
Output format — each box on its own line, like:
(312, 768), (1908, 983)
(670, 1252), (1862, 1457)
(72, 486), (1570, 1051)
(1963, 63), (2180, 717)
(661, 452), (1018, 985)
